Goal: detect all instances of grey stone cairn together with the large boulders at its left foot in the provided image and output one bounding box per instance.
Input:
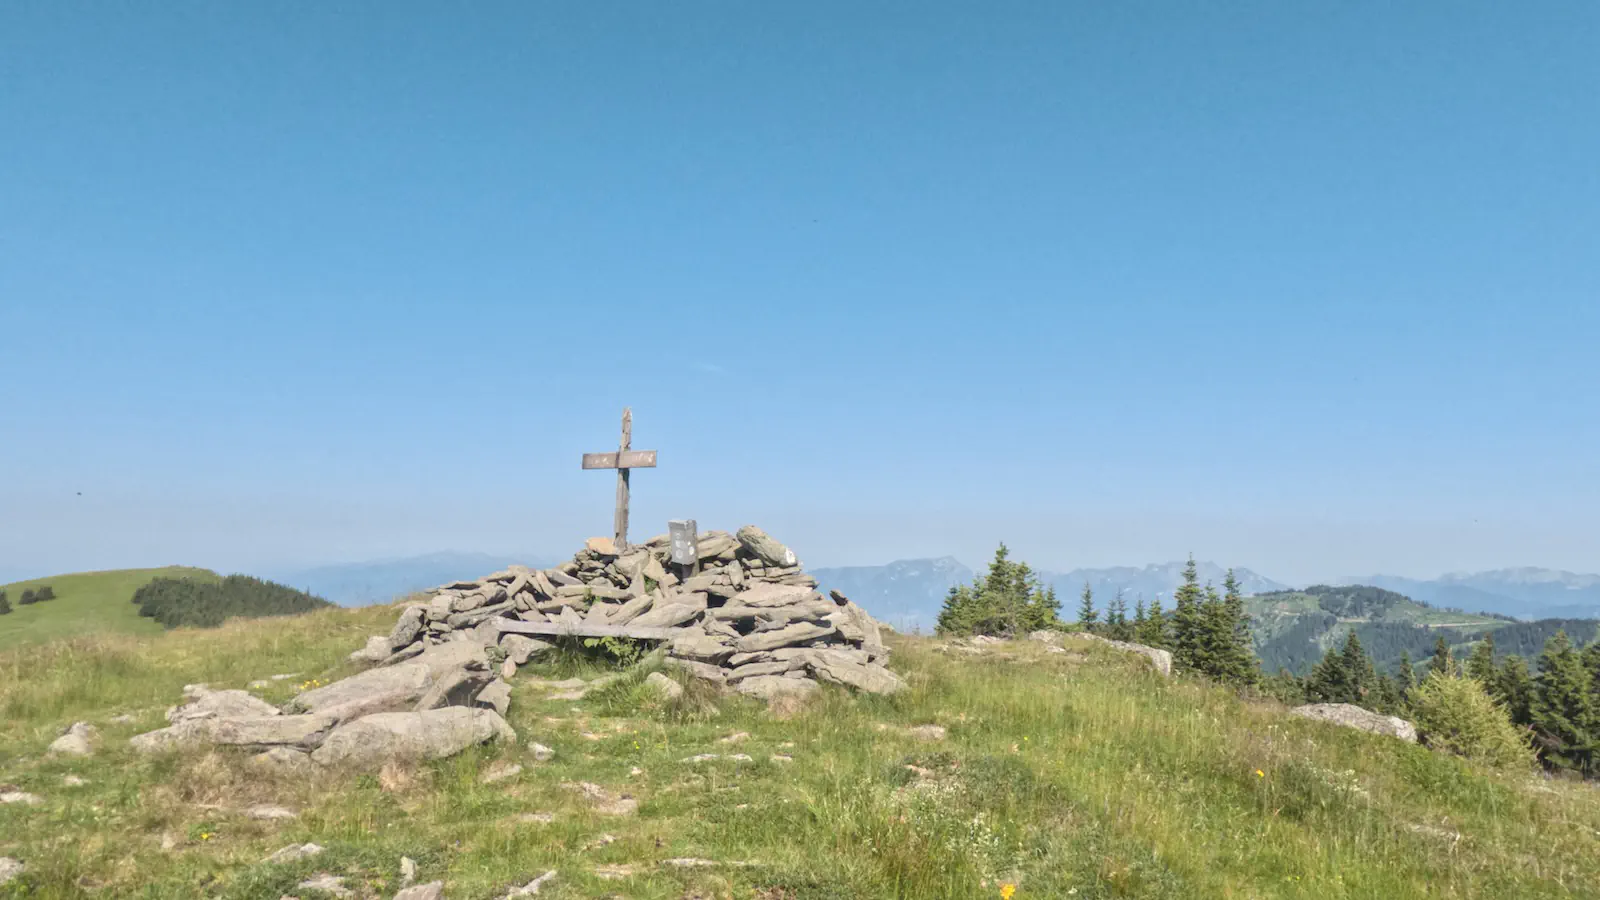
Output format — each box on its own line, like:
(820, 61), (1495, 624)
(124, 525), (902, 770)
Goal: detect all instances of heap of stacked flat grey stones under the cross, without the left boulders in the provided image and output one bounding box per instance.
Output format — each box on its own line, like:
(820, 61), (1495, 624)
(371, 525), (901, 698)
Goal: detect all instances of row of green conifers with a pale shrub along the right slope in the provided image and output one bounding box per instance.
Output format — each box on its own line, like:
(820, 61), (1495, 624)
(938, 544), (1600, 777)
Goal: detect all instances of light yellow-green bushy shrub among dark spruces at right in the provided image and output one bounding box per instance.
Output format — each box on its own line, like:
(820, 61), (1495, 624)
(1411, 671), (1533, 769)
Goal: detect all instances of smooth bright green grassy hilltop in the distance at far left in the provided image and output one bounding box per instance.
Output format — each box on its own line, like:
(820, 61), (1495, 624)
(0, 565), (218, 649)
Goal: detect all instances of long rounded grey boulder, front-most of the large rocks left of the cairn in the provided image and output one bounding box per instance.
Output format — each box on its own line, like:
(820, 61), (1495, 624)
(312, 706), (517, 769)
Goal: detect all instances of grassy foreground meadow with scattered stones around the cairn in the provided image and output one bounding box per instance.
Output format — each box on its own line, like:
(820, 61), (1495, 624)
(0, 607), (1600, 900)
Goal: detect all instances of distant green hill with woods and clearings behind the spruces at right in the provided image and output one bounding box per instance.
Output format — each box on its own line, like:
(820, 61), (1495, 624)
(1245, 585), (1517, 674)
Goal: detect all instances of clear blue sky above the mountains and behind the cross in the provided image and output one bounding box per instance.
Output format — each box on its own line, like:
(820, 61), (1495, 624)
(0, 0), (1600, 580)
